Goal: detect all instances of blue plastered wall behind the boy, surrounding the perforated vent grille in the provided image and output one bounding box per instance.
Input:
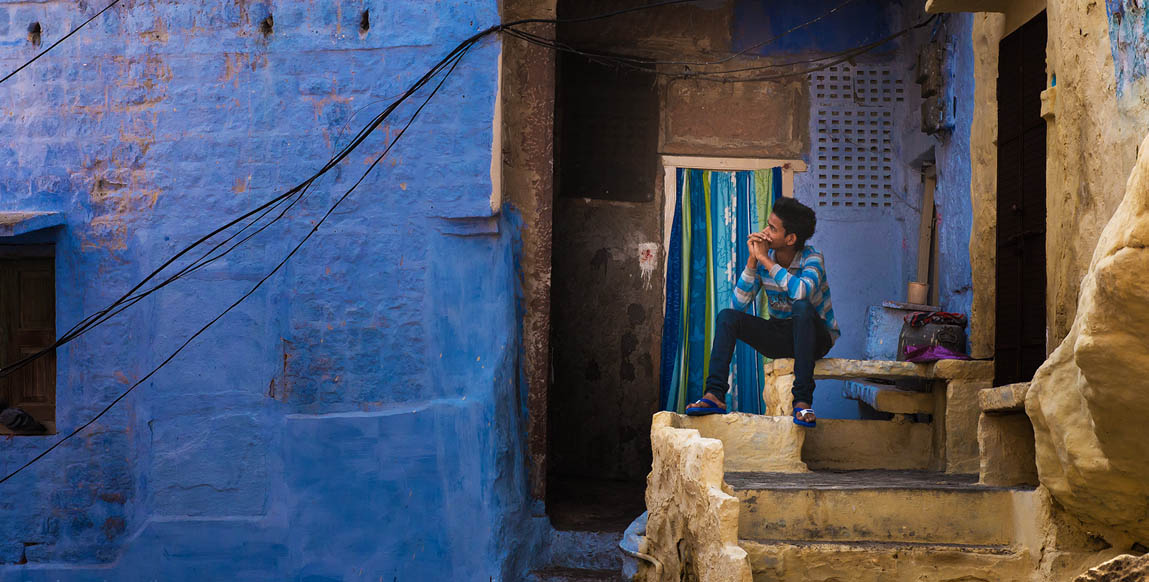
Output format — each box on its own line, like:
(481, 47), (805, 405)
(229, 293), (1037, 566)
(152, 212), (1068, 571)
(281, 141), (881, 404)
(733, 0), (931, 418)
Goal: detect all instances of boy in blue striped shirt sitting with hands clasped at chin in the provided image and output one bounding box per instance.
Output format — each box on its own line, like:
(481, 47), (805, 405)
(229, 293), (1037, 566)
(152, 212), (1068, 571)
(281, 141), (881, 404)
(686, 197), (841, 427)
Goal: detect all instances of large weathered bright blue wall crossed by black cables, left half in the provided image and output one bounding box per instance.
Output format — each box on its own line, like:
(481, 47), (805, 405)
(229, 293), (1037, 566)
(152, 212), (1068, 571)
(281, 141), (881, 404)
(0, 0), (538, 581)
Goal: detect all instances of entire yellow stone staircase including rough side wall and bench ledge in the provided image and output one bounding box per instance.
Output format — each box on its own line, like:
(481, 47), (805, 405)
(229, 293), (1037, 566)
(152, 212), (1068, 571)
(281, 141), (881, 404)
(639, 363), (1109, 582)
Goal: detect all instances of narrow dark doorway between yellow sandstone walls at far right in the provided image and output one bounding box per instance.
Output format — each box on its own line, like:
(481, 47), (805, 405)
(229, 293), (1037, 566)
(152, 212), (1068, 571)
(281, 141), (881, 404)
(994, 11), (1047, 386)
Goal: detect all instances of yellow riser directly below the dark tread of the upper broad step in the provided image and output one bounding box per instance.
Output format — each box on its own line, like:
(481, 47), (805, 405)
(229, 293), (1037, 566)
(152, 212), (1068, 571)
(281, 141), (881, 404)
(735, 489), (1013, 545)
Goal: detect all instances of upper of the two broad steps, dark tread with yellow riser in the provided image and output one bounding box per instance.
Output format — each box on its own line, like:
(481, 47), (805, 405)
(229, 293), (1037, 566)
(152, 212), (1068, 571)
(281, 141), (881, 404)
(726, 471), (1026, 546)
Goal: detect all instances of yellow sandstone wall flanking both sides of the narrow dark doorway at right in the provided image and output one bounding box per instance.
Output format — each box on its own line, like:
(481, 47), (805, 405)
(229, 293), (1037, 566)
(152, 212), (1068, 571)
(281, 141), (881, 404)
(970, 0), (1135, 357)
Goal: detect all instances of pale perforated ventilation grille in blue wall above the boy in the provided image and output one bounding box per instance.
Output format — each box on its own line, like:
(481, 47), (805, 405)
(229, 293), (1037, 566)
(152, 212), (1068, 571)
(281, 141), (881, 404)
(810, 64), (905, 208)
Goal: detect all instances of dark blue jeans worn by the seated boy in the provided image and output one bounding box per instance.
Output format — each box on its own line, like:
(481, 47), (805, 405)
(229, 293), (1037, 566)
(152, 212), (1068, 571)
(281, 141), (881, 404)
(707, 301), (833, 404)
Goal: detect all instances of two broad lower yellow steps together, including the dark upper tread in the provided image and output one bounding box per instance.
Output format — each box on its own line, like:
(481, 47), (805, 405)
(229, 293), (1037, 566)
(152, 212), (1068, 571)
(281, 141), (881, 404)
(726, 470), (1033, 582)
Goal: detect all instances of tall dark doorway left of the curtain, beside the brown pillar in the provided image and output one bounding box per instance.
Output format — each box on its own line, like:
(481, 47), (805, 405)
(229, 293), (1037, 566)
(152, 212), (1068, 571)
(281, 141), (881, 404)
(547, 43), (663, 531)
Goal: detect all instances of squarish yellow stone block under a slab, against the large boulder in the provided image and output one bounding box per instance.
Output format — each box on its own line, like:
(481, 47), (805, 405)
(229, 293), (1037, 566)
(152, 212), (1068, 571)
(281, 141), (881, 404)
(978, 413), (1038, 486)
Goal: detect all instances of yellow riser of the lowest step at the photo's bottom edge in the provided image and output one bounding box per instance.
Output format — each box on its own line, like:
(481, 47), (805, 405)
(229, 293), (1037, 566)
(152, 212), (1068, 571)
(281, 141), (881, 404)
(741, 542), (1036, 582)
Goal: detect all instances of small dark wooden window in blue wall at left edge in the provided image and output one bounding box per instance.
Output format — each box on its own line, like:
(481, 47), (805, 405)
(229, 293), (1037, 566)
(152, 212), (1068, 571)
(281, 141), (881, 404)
(0, 245), (56, 433)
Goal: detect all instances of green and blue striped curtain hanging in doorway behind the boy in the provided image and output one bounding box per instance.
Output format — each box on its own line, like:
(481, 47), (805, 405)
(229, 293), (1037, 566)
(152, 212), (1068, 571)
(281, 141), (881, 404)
(660, 168), (782, 414)
